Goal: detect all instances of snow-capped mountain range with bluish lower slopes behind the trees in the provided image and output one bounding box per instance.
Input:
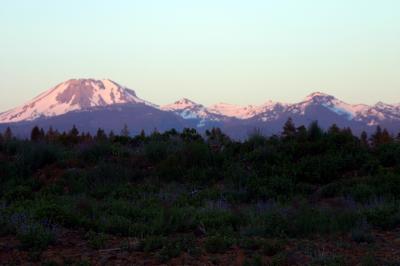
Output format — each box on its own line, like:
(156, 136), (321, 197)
(0, 79), (400, 139)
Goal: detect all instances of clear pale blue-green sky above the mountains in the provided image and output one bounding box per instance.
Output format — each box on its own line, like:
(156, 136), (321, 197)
(0, 0), (400, 111)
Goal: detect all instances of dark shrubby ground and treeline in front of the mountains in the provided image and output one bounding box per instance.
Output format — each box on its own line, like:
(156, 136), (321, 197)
(0, 119), (400, 265)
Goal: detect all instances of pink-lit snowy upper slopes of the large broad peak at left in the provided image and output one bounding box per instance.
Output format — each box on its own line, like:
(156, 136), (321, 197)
(0, 79), (151, 123)
